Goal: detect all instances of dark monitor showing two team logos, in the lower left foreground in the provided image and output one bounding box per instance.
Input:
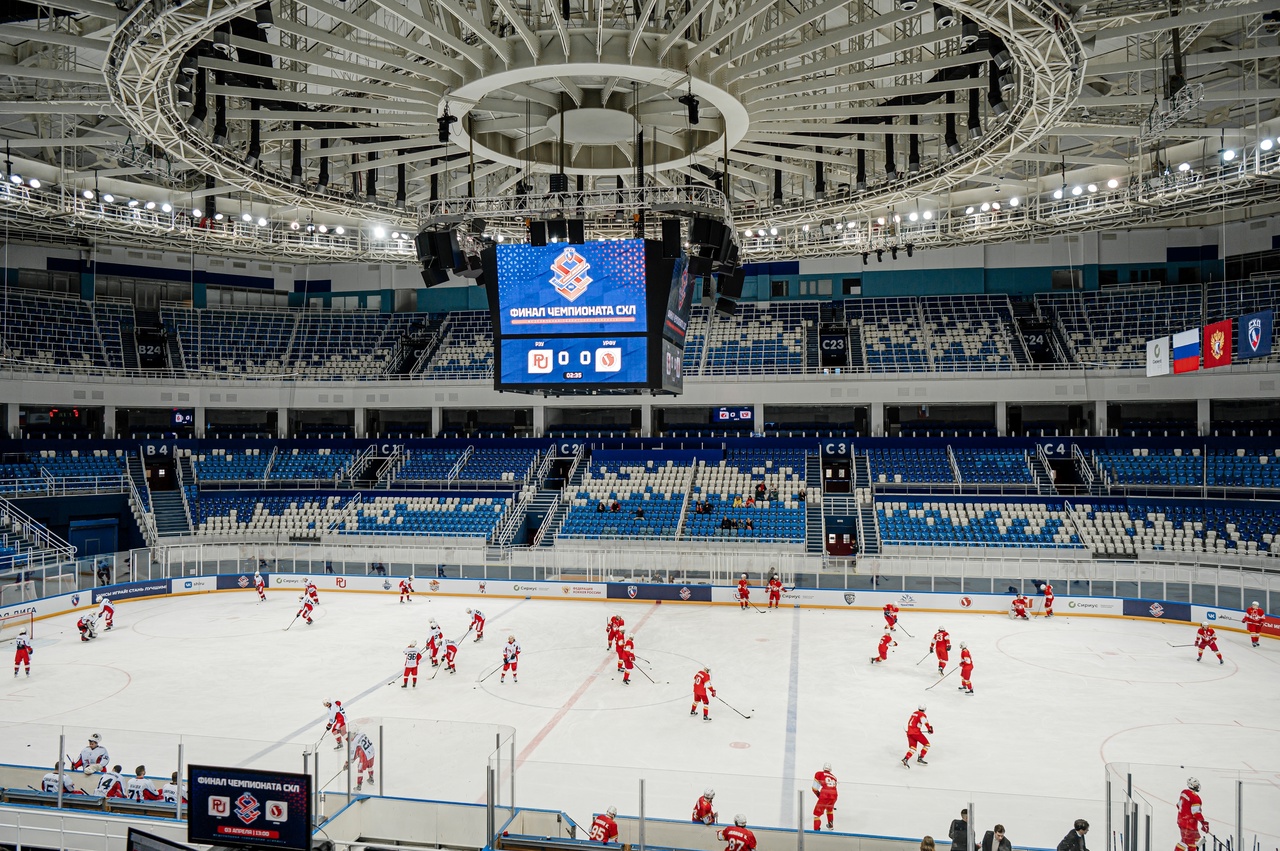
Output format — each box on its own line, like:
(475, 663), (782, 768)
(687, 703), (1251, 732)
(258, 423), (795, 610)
(187, 765), (311, 851)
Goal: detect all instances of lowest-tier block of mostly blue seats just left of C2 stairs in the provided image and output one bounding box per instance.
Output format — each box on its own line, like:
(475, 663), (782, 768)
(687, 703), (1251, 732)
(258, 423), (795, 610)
(348, 495), (511, 539)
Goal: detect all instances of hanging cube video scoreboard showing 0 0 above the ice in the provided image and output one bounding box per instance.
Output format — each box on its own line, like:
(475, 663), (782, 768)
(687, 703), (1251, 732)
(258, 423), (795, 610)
(483, 239), (692, 393)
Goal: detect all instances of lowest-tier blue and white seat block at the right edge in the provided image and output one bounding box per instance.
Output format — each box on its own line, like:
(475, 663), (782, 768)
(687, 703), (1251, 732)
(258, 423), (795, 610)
(1073, 499), (1280, 558)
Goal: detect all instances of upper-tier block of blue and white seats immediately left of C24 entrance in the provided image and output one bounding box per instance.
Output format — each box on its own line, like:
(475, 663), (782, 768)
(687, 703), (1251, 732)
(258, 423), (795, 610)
(920, 296), (1016, 371)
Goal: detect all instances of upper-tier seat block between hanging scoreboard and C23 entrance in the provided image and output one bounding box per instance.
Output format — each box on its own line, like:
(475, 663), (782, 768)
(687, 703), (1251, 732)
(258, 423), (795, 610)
(703, 302), (818, 375)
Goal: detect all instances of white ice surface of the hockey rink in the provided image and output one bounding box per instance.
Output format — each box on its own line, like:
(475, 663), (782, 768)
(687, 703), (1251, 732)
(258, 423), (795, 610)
(0, 590), (1280, 851)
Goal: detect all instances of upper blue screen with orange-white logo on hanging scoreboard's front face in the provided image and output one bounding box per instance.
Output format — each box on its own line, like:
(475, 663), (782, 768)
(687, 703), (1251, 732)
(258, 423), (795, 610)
(497, 239), (648, 337)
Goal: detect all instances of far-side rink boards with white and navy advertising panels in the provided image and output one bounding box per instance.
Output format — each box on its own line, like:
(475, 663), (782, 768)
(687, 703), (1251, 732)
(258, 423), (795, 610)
(0, 572), (1280, 637)
